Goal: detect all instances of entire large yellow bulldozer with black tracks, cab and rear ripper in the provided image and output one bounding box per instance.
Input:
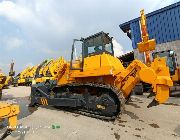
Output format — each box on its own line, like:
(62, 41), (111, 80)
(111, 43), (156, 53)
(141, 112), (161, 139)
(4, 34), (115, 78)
(30, 32), (173, 120)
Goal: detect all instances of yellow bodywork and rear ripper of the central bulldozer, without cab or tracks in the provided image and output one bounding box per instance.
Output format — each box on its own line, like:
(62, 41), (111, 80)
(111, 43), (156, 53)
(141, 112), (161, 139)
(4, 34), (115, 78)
(55, 53), (173, 103)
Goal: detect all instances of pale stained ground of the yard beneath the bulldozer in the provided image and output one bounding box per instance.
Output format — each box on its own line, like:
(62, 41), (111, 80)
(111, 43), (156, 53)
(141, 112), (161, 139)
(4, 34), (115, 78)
(0, 87), (180, 140)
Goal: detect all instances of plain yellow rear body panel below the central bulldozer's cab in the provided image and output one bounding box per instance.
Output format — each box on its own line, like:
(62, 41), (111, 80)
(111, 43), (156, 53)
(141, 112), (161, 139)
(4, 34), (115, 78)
(70, 53), (124, 78)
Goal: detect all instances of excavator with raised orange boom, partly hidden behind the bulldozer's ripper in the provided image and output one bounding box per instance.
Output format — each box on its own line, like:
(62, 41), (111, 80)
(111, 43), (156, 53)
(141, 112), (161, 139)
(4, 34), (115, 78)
(133, 10), (180, 97)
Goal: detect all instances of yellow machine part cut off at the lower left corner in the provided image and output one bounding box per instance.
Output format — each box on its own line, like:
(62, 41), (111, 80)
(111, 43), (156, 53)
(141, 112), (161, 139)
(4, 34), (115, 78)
(0, 103), (20, 140)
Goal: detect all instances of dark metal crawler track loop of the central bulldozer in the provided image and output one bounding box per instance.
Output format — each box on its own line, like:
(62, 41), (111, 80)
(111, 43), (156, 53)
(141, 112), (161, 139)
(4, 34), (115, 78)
(30, 83), (126, 120)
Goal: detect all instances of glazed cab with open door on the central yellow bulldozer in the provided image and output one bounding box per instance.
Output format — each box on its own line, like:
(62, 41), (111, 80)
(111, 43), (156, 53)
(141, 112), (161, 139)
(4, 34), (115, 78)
(70, 32), (114, 70)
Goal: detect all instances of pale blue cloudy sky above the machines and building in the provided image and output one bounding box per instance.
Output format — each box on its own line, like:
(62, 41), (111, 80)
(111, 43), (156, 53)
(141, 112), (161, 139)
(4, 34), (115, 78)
(0, 0), (179, 74)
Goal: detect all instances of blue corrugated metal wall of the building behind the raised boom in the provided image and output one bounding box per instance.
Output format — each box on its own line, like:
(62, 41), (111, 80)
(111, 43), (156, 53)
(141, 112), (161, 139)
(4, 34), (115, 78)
(119, 2), (180, 49)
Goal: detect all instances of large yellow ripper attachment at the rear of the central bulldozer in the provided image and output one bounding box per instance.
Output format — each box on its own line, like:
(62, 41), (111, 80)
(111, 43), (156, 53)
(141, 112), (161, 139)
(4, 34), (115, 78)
(115, 58), (173, 107)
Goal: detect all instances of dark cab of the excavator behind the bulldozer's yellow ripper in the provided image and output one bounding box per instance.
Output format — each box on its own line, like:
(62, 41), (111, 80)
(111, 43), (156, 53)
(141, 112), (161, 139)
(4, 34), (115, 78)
(152, 50), (176, 75)
